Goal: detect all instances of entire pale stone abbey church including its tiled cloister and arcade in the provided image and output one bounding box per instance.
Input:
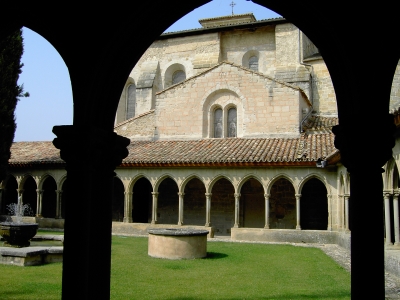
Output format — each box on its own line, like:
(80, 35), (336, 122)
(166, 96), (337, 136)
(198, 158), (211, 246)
(0, 13), (400, 248)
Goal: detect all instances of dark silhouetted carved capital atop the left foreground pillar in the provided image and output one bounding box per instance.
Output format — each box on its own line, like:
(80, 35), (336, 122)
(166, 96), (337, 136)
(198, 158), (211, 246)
(53, 125), (130, 173)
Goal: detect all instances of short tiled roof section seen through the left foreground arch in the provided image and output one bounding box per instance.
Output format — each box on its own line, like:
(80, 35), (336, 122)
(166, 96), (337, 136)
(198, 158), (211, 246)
(8, 142), (65, 165)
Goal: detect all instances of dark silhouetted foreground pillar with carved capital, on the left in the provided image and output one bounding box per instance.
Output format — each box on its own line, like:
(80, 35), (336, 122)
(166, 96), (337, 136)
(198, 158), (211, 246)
(53, 125), (130, 299)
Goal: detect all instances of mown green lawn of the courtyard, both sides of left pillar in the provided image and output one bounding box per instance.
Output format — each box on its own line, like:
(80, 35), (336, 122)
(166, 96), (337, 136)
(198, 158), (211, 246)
(0, 236), (350, 300)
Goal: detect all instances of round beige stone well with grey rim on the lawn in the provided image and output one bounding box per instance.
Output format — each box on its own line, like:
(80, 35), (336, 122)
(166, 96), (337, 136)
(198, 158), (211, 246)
(148, 228), (208, 259)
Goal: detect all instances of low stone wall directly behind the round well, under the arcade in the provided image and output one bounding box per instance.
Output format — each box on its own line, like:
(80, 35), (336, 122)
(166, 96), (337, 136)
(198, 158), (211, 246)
(112, 222), (214, 238)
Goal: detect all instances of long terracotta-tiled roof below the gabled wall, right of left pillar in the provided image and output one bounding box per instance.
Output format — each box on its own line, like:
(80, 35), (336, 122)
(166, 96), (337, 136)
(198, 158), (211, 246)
(122, 133), (336, 166)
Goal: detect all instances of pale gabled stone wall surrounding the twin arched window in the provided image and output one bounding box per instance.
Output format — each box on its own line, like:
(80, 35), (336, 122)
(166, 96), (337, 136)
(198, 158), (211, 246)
(155, 63), (302, 139)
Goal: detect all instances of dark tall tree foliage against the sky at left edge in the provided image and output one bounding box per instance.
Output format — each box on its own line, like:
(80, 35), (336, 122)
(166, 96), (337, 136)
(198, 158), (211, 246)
(0, 28), (29, 182)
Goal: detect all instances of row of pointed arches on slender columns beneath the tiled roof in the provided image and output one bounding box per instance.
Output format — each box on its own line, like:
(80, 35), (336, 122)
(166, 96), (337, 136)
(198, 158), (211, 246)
(1, 168), (345, 235)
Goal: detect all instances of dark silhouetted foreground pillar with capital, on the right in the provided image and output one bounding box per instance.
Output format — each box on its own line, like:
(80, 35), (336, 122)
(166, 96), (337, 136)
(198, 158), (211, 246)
(332, 116), (396, 299)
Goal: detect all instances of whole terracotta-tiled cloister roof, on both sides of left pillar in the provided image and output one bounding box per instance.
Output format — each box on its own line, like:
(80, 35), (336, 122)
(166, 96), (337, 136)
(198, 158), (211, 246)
(9, 133), (337, 167)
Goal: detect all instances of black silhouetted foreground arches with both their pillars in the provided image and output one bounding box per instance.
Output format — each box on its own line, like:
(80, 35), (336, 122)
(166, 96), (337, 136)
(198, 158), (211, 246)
(0, 0), (400, 299)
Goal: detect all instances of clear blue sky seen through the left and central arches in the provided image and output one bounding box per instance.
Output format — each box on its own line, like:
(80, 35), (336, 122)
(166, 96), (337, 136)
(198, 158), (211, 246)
(14, 0), (280, 142)
